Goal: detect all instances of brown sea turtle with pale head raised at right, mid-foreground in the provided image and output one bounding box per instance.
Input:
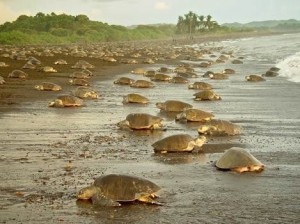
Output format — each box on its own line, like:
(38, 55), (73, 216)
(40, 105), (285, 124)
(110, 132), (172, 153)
(152, 134), (206, 153)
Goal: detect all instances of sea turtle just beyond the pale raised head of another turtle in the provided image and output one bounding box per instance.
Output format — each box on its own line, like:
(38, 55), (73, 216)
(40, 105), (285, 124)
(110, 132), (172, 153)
(198, 119), (241, 135)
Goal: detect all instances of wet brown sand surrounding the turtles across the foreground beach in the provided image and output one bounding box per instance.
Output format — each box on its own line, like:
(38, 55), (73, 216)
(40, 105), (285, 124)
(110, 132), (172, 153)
(0, 34), (300, 223)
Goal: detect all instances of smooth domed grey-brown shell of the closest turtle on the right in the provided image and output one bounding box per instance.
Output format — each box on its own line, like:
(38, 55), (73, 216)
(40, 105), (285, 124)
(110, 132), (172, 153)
(215, 147), (263, 170)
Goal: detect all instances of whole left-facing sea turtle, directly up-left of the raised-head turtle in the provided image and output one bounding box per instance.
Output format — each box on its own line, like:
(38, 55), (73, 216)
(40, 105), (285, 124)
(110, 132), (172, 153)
(117, 113), (163, 130)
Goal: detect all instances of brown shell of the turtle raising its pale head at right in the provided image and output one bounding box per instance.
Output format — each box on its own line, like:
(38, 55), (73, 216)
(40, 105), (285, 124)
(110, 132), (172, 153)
(152, 134), (204, 152)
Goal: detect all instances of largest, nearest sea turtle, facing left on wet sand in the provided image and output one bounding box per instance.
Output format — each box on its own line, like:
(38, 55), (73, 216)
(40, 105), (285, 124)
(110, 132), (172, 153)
(77, 174), (162, 206)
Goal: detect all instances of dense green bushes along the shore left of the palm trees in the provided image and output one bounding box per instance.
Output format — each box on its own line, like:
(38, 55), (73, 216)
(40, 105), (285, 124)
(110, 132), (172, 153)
(0, 12), (175, 45)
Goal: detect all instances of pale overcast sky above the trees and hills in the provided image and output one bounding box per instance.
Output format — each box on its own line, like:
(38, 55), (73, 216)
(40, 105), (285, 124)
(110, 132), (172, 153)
(0, 0), (300, 26)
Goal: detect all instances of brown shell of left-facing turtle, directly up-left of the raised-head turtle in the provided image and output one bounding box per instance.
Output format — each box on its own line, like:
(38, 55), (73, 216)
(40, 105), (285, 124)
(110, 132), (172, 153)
(126, 113), (162, 129)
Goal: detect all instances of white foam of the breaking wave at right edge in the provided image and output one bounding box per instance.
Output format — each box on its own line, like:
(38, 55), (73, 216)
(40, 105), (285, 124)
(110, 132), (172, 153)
(276, 52), (300, 83)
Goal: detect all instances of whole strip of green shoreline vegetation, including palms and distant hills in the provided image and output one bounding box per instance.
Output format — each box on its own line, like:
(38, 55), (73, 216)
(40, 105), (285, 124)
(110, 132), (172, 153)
(0, 11), (300, 45)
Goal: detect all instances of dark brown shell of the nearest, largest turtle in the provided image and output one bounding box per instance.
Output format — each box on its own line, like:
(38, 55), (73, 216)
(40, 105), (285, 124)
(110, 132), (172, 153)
(94, 174), (160, 202)
